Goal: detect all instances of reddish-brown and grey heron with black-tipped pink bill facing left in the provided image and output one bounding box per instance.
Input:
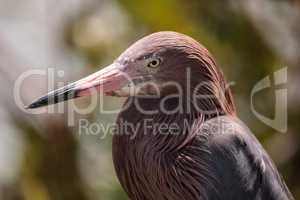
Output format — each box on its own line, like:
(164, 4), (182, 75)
(27, 31), (293, 200)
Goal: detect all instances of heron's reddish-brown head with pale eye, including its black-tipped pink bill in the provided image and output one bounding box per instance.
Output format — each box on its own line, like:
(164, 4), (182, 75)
(28, 31), (234, 115)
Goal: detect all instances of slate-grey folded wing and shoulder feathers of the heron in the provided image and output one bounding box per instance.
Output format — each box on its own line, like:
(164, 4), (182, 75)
(195, 117), (293, 200)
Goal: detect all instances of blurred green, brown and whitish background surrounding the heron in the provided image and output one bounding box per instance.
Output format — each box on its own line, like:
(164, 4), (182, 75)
(0, 0), (300, 200)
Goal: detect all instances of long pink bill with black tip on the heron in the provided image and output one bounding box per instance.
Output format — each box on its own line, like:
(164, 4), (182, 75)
(26, 63), (129, 109)
